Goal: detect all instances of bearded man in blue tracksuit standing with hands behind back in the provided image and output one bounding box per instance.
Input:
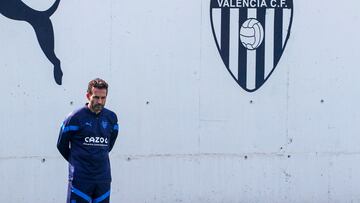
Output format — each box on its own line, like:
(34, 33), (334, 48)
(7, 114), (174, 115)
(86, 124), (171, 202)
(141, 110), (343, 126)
(57, 78), (119, 203)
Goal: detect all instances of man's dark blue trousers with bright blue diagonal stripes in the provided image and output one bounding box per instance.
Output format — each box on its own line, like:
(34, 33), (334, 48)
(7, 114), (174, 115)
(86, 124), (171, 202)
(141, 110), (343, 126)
(66, 180), (110, 203)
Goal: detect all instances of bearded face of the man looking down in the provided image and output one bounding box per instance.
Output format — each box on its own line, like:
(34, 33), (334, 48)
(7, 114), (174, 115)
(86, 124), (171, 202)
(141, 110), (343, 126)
(86, 87), (107, 113)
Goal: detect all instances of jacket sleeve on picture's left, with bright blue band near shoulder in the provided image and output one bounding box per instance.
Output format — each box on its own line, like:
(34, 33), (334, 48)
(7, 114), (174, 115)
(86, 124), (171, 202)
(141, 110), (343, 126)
(57, 116), (79, 161)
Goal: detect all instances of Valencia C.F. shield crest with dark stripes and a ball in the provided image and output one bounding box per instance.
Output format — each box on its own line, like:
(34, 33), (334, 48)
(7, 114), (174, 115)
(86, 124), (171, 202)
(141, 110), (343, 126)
(210, 0), (293, 92)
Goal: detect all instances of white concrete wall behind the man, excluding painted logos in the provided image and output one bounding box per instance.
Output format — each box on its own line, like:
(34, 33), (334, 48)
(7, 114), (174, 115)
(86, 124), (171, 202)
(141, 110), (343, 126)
(0, 0), (360, 203)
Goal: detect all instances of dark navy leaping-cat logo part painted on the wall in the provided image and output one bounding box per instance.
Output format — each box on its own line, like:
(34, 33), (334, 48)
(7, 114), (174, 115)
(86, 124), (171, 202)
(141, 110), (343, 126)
(0, 0), (63, 85)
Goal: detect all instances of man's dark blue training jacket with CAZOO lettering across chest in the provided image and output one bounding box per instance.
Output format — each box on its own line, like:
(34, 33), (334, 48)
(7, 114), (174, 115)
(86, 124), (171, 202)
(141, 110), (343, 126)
(57, 106), (119, 182)
